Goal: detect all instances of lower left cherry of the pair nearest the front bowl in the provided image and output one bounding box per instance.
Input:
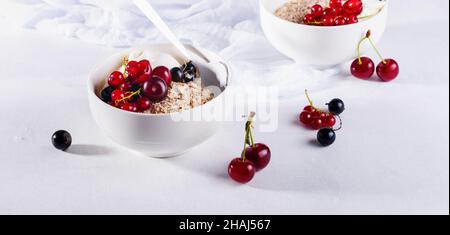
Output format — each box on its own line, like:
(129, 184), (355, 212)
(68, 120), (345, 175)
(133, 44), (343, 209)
(228, 158), (256, 184)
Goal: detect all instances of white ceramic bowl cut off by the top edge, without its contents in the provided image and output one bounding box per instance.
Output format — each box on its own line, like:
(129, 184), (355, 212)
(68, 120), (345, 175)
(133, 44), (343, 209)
(260, 0), (388, 67)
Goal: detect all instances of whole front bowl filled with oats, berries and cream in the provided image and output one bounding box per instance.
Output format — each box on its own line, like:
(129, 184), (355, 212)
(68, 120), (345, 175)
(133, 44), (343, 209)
(88, 44), (230, 157)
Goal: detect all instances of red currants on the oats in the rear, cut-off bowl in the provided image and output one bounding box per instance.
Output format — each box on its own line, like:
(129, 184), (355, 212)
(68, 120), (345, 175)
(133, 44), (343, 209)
(303, 0), (363, 26)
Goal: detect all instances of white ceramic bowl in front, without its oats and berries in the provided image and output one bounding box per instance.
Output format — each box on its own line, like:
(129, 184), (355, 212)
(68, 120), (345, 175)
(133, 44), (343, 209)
(88, 44), (230, 157)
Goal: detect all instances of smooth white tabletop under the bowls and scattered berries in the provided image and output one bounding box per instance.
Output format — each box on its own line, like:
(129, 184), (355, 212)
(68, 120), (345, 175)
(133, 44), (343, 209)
(0, 1), (449, 214)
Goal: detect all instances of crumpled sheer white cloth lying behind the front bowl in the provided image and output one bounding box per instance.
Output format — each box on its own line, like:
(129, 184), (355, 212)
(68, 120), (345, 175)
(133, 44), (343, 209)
(3, 0), (356, 97)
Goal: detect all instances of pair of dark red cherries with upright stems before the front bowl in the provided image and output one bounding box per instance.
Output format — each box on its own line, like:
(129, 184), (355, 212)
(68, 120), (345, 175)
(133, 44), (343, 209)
(228, 113), (271, 184)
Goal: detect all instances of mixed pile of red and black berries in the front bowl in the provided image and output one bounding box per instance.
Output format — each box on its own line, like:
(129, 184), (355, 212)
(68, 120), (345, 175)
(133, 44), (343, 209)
(100, 58), (197, 112)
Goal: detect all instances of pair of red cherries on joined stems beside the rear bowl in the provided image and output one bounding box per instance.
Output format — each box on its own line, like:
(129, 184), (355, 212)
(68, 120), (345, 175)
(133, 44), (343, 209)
(350, 30), (400, 82)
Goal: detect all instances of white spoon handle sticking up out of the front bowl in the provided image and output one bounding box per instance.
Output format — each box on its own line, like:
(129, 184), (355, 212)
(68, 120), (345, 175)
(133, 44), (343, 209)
(133, 0), (189, 61)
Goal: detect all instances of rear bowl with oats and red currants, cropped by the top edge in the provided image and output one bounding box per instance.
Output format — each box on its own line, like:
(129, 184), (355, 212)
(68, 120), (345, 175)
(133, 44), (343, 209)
(260, 0), (388, 68)
